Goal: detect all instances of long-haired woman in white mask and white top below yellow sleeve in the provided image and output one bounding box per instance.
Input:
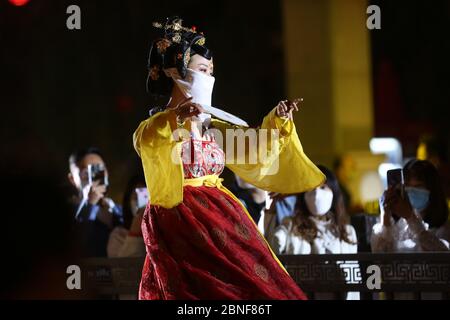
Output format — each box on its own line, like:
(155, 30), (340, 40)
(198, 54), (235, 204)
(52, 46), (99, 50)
(268, 165), (359, 300)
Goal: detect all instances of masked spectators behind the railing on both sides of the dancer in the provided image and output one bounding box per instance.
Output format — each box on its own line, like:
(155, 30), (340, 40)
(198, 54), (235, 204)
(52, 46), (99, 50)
(68, 136), (450, 264)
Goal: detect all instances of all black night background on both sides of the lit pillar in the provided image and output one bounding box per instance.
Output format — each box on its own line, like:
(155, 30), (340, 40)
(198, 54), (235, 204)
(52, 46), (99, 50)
(0, 0), (450, 200)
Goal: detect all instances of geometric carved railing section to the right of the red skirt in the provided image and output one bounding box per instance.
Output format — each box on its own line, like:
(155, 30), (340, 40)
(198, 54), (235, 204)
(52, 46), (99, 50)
(279, 252), (450, 292)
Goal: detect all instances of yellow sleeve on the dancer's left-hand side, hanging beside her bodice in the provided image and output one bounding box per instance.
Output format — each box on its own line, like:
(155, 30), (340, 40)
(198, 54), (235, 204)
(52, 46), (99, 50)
(133, 110), (183, 208)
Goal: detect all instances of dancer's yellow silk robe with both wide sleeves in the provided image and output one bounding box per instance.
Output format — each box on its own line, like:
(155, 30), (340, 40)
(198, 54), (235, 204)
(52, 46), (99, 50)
(133, 109), (325, 208)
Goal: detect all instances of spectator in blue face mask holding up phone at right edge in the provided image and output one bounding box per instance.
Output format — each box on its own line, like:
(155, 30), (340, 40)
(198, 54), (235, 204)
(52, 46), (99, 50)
(371, 160), (450, 252)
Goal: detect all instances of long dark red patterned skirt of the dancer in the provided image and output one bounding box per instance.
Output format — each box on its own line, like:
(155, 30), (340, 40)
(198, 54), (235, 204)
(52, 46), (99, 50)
(139, 186), (306, 300)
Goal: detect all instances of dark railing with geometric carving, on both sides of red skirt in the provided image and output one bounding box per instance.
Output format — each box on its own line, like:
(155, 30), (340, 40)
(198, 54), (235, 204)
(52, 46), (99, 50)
(80, 252), (450, 296)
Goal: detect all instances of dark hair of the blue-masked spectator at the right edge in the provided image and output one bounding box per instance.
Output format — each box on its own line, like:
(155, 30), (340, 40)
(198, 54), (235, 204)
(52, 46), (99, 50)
(403, 159), (448, 228)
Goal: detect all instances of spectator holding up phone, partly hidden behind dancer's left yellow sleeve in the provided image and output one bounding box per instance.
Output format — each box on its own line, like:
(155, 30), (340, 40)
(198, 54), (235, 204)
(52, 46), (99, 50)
(107, 175), (146, 258)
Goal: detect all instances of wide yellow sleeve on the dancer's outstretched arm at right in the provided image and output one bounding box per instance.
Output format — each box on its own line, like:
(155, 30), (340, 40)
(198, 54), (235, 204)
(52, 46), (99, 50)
(213, 108), (325, 194)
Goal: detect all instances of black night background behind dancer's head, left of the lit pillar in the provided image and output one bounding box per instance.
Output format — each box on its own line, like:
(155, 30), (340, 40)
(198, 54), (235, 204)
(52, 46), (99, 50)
(0, 0), (283, 198)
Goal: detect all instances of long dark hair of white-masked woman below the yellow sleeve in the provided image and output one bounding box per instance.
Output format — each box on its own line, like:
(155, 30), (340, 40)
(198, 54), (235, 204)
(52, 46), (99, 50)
(286, 165), (354, 244)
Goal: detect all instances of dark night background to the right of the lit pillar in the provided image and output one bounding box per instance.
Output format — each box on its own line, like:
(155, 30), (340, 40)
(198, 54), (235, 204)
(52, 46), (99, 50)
(371, 0), (450, 156)
